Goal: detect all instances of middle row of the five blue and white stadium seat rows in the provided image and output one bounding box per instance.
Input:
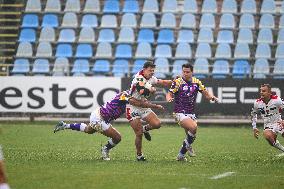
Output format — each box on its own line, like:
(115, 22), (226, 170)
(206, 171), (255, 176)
(19, 27), (284, 44)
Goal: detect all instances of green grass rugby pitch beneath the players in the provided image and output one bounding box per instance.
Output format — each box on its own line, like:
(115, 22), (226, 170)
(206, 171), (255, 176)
(0, 122), (284, 189)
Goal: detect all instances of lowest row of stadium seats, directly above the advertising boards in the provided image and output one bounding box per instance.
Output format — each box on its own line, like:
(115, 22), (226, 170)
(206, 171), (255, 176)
(12, 57), (284, 79)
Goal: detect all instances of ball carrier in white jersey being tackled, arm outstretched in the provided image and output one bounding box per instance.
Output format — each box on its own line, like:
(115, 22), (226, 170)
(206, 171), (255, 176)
(126, 60), (172, 161)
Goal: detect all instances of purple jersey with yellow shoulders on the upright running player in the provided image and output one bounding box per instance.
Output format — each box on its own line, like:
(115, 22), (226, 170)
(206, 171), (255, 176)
(169, 77), (206, 114)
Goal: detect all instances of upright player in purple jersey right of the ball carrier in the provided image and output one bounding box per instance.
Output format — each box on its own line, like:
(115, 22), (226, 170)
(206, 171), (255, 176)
(166, 64), (218, 161)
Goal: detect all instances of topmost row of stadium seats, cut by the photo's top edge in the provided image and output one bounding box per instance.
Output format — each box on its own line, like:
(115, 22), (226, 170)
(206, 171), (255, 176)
(25, 0), (284, 14)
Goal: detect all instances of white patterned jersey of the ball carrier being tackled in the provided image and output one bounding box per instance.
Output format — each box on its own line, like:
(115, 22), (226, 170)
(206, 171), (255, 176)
(130, 70), (158, 100)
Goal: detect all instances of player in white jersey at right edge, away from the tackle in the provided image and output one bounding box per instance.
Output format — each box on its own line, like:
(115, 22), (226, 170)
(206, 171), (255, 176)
(251, 84), (284, 152)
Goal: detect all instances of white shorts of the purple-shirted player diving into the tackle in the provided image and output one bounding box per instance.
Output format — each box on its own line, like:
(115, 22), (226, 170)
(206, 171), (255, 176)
(90, 108), (111, 132)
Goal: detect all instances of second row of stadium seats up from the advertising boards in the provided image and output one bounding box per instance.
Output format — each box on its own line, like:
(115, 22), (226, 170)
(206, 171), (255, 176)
(16, 42), (284, 59)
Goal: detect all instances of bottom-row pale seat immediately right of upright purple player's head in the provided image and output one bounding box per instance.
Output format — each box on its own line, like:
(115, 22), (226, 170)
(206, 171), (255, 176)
(194, 58), (209, 78)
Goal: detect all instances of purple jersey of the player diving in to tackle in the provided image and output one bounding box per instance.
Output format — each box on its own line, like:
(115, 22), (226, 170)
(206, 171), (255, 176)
(100, 91), (131, 123)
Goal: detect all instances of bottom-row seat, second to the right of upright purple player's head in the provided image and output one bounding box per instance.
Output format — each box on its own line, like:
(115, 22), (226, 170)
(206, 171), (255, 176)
(212, 60), (230, 79)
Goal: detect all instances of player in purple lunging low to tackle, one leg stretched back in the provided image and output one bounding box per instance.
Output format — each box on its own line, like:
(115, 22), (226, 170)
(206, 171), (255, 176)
(54, 91), (164, 160)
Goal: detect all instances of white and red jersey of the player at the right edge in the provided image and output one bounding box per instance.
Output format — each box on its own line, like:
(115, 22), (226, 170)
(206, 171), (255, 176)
(251, 95), (284, 127)
